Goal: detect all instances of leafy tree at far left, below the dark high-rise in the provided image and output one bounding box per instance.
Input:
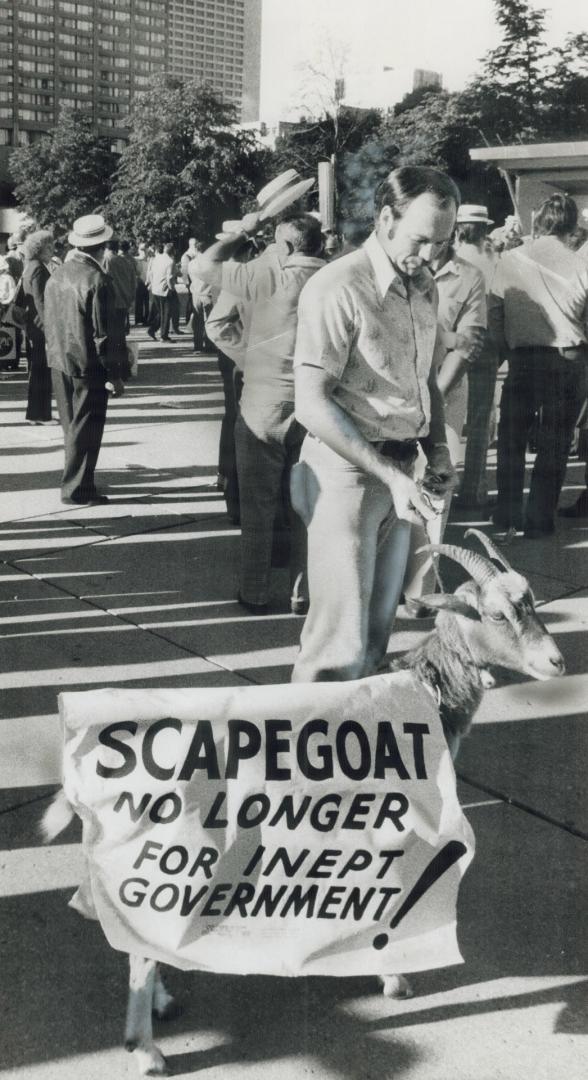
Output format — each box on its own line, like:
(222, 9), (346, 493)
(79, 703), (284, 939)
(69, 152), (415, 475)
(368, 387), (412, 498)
(10, 109), (117, 234)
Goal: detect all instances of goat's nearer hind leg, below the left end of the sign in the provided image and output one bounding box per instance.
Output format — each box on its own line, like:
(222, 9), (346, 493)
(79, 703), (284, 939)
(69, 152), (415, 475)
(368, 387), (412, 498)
(124, 956), (168, 1077)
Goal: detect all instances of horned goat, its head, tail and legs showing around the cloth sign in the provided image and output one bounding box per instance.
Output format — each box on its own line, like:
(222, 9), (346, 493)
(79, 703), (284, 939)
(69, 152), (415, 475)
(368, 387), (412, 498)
(43, 529), (565, 1076)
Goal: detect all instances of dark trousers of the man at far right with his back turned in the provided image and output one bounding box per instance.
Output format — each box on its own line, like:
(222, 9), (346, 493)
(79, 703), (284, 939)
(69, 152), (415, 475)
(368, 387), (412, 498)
(494, 348), (588, 529)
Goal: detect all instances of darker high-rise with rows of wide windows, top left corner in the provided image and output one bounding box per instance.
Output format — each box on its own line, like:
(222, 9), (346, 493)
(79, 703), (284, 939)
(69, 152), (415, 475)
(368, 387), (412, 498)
(0, 0), (168, 152)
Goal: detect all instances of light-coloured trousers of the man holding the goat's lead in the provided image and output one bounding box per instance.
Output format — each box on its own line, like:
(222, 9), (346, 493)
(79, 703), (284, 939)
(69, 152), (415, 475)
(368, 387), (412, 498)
(291, 435), (413, 683)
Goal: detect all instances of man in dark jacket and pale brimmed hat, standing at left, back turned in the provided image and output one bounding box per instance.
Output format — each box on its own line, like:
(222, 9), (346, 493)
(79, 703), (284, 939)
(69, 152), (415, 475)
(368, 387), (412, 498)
(45, 214), (129, 505)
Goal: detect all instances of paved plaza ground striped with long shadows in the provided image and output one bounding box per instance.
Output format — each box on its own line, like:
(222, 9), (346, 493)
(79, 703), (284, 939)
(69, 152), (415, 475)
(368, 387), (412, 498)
(0, 330), (588, 1080)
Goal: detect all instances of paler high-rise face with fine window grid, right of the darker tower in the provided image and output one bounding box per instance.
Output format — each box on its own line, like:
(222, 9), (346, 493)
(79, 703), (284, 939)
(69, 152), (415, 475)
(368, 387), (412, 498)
(168, 0), (262, 121)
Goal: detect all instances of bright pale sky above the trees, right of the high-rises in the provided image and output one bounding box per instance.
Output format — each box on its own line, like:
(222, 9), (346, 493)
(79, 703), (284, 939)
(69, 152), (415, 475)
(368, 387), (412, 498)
(260, 0), (588, 122)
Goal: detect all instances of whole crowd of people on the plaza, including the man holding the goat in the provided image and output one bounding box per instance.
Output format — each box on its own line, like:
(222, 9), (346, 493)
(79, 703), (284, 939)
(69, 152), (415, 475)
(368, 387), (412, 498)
(0, 167), (588, 681)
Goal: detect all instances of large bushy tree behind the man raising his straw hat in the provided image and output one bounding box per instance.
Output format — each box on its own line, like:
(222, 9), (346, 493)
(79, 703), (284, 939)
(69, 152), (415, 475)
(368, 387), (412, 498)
(109, 76), (270, 243)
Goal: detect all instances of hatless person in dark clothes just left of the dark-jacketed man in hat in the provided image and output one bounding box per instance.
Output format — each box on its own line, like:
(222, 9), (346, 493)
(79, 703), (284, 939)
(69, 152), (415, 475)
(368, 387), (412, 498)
(22, 229), (53, 423)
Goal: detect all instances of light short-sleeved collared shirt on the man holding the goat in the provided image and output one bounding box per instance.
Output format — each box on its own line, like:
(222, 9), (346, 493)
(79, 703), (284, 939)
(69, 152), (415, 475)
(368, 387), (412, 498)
(294, 233), (437, 442)
